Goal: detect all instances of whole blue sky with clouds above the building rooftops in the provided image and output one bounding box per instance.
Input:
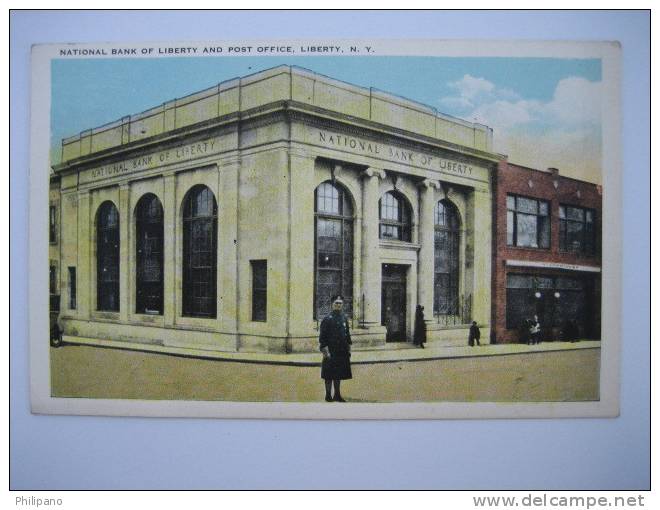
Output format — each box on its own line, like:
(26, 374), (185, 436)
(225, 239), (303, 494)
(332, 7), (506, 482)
(51, 56), (601, 182)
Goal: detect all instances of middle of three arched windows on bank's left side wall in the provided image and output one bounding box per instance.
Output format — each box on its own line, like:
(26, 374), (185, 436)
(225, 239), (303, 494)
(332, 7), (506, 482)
(135, 193), (163, 315)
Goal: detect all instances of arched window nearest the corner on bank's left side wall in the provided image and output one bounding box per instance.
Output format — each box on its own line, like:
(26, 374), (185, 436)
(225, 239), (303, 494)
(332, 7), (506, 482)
(183, 185), (218, 317)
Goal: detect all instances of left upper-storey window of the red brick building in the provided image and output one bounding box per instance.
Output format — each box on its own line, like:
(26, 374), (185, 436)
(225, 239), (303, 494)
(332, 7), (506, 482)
(506, 195), (550, 248)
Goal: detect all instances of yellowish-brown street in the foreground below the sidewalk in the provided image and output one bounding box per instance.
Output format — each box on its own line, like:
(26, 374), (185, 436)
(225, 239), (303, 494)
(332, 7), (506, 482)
(50, 345), (600, 405)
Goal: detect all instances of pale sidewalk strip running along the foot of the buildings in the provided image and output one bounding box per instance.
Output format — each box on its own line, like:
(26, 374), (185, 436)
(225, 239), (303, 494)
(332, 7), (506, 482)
(63, 336), (600, 366)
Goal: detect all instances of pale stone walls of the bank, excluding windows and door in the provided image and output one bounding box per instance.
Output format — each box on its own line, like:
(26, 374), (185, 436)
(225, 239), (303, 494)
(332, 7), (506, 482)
(51, 66), (500, 352)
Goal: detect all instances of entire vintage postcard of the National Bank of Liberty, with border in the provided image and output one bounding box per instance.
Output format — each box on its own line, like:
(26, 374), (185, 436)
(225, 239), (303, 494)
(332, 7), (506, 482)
(30, 40), (621, 419)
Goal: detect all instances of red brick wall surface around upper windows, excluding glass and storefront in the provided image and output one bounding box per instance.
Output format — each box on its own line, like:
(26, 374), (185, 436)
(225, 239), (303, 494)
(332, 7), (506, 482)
(491, 161), (602, 343)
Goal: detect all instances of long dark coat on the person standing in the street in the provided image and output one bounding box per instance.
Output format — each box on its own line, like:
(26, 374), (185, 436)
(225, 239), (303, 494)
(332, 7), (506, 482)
(319, 311), (353, 381)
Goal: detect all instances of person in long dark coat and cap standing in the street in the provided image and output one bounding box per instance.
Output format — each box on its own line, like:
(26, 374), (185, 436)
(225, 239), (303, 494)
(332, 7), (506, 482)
(319, 295), (353, 402)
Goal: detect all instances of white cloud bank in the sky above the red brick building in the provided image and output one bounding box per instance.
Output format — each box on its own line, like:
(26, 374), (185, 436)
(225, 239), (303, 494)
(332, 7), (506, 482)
(441, 74), (601, 182)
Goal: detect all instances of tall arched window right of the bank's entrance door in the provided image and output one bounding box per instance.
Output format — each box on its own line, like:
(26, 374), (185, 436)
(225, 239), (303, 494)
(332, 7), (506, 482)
(433, 200), (460, 315)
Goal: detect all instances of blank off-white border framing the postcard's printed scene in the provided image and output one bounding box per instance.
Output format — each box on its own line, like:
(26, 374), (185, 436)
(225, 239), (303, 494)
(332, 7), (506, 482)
(28, 39), (622, 419)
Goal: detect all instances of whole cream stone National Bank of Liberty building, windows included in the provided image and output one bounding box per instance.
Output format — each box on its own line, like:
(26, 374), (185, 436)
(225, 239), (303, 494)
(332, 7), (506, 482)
(50, 66), (502, 353)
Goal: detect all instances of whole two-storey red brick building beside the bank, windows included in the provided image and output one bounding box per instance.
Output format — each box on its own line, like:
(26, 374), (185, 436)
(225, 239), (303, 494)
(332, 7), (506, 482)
(491, 160), (602, 343)
